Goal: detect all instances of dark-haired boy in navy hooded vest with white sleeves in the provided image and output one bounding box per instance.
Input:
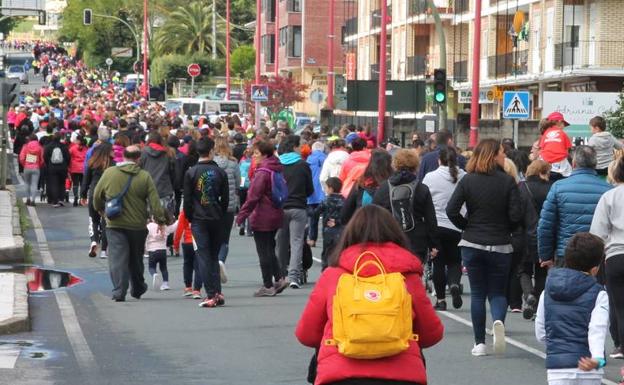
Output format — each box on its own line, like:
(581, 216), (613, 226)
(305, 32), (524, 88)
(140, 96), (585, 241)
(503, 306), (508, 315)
(535, 233), (609, 385)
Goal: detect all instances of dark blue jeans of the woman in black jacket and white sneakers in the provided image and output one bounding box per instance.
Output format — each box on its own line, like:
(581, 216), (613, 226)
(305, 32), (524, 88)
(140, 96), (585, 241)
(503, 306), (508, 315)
(461, 247), (511, 344)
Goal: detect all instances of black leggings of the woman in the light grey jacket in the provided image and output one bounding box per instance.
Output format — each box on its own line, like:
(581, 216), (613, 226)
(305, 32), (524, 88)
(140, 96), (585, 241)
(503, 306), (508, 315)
(433, 227), (461, 300)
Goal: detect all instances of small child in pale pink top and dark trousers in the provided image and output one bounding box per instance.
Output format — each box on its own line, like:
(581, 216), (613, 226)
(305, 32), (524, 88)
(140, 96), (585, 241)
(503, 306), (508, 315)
(145, 219), (178, 290)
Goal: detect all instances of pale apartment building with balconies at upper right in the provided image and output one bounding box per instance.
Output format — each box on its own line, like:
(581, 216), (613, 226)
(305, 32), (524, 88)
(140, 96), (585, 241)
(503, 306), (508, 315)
(345, 0), (624, 127)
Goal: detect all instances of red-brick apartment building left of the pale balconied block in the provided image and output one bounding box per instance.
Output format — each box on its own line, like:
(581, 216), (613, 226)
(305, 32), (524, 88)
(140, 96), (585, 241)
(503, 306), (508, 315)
(255, 0), (355, 115)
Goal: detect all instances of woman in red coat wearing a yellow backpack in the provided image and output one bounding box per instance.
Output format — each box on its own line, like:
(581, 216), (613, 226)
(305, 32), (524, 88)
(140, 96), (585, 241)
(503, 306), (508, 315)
(295, 205), (444, 385)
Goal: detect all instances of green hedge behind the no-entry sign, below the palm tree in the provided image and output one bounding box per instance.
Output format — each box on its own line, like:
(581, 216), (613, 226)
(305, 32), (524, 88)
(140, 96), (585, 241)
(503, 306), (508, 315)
(151, 54), (225, 84)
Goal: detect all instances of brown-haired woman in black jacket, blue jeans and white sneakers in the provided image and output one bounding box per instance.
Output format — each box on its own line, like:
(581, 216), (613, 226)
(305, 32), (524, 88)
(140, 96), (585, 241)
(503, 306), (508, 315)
(446, 139), (522, 356)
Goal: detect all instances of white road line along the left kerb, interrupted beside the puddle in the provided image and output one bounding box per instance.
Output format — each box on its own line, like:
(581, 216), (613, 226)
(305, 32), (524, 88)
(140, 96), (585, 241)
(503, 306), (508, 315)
(28, 206), (96, 372)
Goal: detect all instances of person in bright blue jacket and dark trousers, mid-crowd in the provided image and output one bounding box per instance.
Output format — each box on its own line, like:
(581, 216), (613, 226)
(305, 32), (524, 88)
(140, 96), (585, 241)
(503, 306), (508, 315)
(306, 141), (327, 247)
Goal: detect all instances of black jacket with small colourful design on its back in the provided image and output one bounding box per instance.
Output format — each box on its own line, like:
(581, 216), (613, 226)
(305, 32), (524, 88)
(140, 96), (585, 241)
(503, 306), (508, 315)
(184, 160), (229, 222)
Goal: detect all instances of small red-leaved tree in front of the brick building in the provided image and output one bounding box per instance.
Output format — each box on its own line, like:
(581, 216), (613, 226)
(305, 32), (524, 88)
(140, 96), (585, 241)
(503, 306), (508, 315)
(245, 75), (308, 116)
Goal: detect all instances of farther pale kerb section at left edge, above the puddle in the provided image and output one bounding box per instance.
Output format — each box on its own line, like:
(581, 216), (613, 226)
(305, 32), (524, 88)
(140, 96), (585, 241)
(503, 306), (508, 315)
(0, 186), (25, 263)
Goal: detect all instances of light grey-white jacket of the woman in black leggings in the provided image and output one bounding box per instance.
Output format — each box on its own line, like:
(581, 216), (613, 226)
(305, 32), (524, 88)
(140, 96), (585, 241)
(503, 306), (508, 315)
(422, 166), (466, 231)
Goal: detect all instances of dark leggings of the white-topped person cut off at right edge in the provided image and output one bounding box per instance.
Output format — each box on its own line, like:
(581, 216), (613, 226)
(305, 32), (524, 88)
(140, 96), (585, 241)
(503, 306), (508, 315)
(605, 254), (624, 347)
